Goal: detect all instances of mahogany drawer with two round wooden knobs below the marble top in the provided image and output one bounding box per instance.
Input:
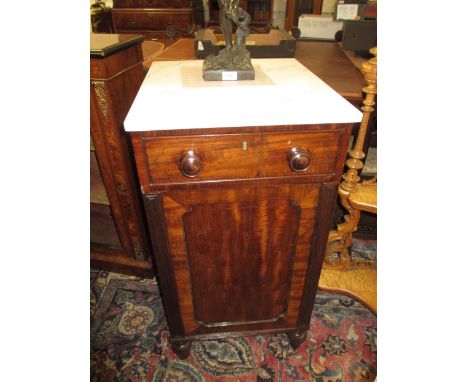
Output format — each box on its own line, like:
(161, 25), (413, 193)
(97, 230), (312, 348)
(138, 130), (344, 185)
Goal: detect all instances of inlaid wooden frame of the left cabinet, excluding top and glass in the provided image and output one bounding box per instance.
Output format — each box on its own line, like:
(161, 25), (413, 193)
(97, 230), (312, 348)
(90, 38), (152, 275)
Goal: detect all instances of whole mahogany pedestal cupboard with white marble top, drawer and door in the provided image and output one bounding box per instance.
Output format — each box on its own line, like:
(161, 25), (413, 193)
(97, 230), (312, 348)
(124, 59), (362, 358)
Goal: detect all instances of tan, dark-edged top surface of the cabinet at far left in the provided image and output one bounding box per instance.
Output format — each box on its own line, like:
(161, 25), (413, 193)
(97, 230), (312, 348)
(89, 33), (144, 57)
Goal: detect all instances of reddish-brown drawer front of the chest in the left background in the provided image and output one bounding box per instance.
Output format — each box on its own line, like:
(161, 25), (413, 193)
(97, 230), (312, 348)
(112, 8), (192, 31)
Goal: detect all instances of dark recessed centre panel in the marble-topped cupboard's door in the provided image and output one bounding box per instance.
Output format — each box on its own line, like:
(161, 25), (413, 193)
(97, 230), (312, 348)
(184, 200), (300, 326)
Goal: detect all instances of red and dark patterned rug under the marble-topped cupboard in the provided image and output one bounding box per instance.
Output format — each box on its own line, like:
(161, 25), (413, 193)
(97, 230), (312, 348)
(91, 241), (377, 382)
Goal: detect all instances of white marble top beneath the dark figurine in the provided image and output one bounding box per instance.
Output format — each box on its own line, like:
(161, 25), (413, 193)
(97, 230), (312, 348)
(124, 58), (362, 132)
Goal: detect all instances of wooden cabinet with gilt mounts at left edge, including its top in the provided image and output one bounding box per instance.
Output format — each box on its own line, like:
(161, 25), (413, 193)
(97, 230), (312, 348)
(90, 34), (153, 276)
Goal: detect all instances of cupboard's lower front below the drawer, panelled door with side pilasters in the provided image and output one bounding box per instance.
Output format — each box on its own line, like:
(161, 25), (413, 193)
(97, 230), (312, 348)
(145, 184), (332, 336)
